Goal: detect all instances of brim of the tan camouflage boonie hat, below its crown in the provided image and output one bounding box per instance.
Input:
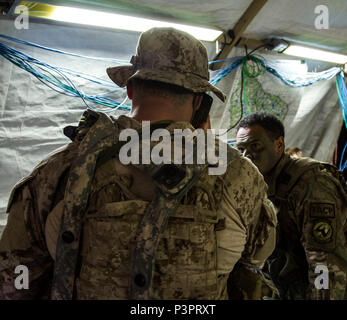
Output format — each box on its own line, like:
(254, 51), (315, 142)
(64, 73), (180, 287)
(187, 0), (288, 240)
(106, 66), (226, 102)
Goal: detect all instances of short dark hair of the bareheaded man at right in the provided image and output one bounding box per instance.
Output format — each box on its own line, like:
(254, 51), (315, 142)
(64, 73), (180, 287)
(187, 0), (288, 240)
(236, 112), (284, 140)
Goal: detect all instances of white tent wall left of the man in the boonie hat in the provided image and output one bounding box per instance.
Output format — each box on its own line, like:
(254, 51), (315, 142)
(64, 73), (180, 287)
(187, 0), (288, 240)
(0, 19), (143, 232)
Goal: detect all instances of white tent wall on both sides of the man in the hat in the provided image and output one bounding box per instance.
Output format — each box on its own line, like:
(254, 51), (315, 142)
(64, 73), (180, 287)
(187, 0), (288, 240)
(0, 19), (342, 233)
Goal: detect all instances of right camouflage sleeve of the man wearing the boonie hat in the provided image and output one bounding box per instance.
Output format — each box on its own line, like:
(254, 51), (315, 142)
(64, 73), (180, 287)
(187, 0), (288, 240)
(217, 158), (277, 274)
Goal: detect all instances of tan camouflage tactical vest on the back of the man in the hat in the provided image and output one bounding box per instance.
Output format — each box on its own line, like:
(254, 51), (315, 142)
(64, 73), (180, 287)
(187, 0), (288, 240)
(42, 110), (234, 299)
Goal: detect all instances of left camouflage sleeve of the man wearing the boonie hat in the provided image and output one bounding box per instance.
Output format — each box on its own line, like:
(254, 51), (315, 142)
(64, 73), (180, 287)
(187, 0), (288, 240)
(0, 184), (53, 300)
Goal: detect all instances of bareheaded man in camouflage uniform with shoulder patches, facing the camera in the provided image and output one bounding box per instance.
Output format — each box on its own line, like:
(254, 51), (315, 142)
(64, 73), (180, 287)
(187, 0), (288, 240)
(234, 113), (347, 300)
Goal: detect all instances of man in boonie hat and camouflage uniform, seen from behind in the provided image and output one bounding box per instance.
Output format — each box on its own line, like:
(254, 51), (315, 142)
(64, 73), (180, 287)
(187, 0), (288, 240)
(0, 28), (277, 299)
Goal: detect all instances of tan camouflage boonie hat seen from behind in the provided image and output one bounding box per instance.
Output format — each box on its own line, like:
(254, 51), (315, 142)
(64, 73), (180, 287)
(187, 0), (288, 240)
(107, 28), (226, 102)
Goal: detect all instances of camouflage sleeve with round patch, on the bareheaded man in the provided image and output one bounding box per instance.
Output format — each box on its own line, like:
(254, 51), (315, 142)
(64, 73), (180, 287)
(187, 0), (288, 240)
(290, 167), (347, 300)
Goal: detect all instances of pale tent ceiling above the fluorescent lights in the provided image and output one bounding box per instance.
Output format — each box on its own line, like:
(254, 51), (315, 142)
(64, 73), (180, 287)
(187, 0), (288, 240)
(36, 0), (347, 54)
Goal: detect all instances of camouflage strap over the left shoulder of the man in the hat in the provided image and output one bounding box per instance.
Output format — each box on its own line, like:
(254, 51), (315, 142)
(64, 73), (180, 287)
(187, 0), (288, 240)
(51, 113), (118, 300)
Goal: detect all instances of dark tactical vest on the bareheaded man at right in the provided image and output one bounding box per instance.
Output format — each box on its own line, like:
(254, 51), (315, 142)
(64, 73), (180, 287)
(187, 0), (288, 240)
(263, 158), (347, 300)
